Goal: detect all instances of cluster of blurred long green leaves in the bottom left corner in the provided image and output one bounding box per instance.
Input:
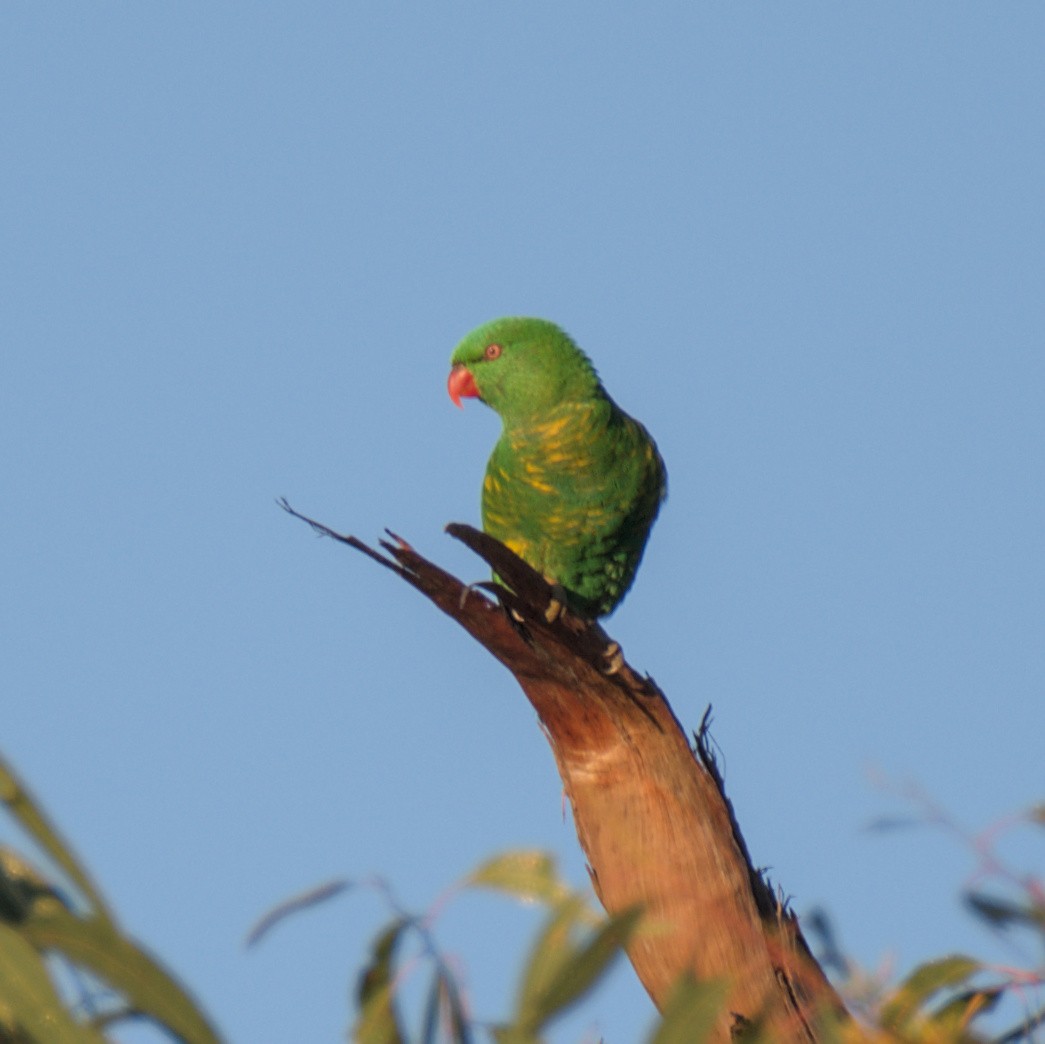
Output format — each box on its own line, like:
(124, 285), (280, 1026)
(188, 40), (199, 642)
(0, 759), (218, 1044)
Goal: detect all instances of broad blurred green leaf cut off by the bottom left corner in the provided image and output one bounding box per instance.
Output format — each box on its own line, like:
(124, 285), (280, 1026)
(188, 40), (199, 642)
(0, 925), (106, 1044)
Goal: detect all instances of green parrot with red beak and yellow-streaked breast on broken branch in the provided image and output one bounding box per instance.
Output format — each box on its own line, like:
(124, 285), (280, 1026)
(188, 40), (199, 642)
(447, 318), (668, 620)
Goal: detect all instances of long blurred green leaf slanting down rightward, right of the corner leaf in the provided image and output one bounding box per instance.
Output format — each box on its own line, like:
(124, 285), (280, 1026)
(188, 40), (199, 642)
(21, 900), (219, 1044)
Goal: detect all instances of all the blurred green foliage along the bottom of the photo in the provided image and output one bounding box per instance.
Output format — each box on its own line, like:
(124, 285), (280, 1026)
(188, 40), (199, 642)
(0, 744), (1045, 1044)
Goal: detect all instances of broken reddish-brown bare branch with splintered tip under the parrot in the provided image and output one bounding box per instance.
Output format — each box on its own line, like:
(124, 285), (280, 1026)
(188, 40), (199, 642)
(281, 501), (844, 1041)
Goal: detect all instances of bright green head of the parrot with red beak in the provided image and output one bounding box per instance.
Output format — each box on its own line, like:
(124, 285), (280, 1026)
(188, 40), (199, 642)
(447, 318), (601, 421)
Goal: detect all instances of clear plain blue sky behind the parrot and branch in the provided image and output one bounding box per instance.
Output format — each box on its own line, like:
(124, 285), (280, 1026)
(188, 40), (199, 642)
(0, 2), (1045, 1041)
